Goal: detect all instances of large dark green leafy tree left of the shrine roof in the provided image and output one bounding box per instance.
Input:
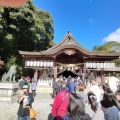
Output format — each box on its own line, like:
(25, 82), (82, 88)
(0, 1), (54, 77)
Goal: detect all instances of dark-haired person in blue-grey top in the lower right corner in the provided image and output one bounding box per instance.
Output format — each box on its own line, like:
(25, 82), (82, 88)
(100, 84), (120, 120)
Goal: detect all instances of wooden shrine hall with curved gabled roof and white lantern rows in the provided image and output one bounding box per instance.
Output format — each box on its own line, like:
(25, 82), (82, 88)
(19, 32), (120, 83)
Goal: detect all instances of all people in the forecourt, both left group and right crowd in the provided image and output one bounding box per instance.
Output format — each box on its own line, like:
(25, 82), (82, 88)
(17, 77), (120, 120)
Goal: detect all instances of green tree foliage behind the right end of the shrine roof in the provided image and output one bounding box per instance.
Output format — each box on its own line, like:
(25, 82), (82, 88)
(93, 41), (120, 66)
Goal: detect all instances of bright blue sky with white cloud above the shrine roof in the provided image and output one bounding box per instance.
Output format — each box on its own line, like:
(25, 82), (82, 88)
(33, 0), (120, 50)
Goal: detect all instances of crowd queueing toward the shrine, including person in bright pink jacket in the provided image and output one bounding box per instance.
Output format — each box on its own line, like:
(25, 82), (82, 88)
(48, 78), (120, 120)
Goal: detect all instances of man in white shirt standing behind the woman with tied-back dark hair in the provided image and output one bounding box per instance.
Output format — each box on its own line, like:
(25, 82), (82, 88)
(90, 80), (101, 103)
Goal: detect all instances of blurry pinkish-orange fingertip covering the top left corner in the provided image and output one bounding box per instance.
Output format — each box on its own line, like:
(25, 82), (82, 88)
(0, 0), (28, 8)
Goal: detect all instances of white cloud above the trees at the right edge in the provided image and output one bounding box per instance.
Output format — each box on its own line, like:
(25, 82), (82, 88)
(103, 28), (120, 43)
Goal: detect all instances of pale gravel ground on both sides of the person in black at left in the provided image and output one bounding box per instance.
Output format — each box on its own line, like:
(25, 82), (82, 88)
(0, 93), (53, 120)
